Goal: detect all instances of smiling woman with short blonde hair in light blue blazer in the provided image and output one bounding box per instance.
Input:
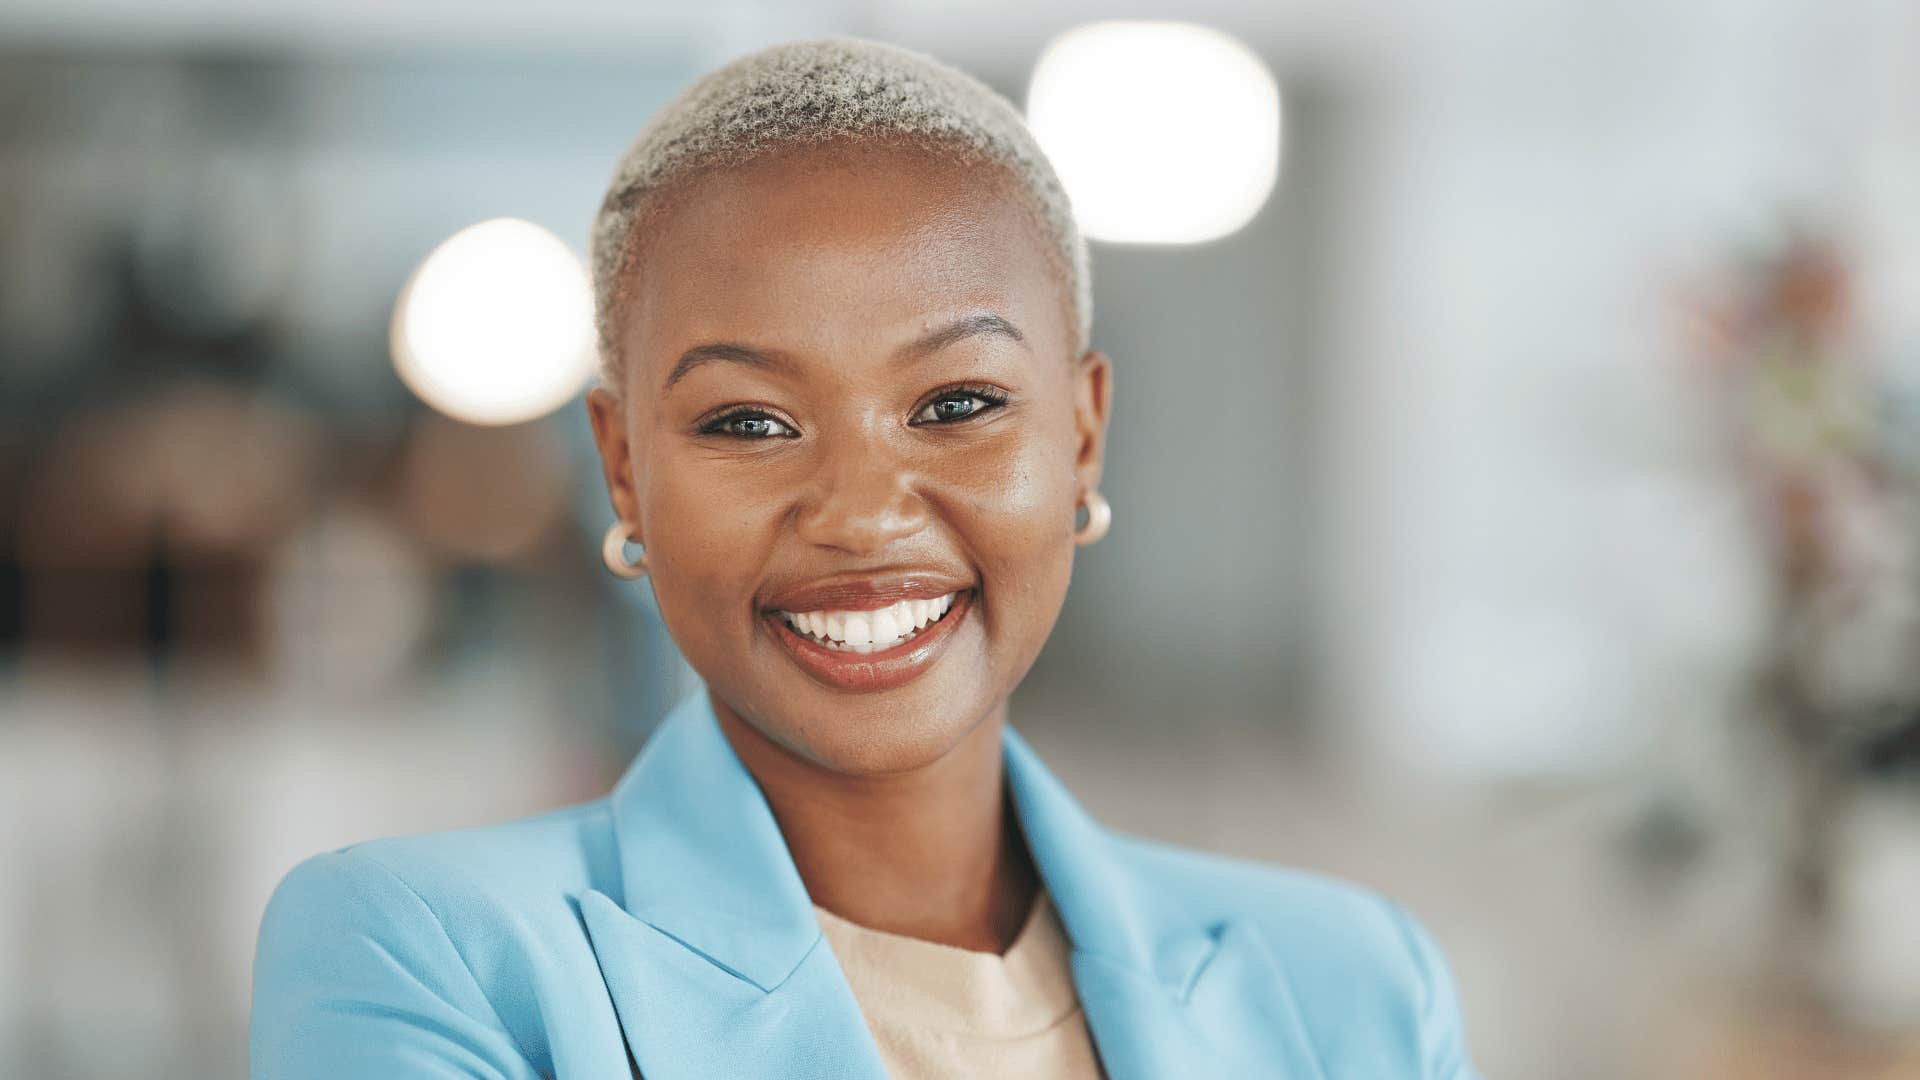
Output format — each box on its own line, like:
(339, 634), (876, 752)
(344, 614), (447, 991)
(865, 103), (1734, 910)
(252, 40), (1473, 1080)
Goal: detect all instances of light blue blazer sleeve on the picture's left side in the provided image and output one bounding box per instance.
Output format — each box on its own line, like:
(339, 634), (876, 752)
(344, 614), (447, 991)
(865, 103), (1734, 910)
(248, 849), (536, 1080)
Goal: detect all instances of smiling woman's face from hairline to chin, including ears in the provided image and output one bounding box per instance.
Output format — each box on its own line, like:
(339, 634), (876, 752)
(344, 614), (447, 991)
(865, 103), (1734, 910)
(589, 144), (1108, 774)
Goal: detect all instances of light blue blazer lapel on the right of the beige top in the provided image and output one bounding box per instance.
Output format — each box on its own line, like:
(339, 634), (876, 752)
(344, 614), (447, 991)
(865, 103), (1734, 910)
(1006, 728), (1325, 1080)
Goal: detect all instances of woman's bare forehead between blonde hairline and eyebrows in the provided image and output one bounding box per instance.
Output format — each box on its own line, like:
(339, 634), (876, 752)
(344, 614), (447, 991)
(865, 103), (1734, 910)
(622, 148), (1071, 363)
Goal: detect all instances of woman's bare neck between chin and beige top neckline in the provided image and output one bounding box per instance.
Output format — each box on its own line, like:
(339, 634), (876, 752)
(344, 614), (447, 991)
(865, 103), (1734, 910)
(714, 701), (1039, 953)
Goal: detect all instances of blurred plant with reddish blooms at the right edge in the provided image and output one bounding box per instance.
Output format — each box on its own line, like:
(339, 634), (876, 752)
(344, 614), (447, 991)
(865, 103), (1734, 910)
(1695, 229), (1920, 1014)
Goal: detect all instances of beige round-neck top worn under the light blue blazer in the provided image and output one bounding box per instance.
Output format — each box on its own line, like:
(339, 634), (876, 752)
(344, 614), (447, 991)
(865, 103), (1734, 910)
(814, 890), (1100, 1080)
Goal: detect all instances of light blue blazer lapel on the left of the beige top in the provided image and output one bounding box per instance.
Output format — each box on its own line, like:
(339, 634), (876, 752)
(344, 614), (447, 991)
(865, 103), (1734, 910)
(580, 688), (885, 1080)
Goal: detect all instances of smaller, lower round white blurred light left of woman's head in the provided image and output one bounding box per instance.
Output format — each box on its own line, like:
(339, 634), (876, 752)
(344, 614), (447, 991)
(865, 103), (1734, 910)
(392, 217), (593, 425)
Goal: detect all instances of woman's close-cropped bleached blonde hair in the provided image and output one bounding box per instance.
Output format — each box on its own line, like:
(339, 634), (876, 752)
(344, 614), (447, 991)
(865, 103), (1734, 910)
(589, 37), (1092, 388)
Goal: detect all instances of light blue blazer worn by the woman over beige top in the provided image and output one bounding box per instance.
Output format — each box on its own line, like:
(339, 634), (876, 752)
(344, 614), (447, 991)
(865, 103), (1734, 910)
(250, 688), (1476, 1080)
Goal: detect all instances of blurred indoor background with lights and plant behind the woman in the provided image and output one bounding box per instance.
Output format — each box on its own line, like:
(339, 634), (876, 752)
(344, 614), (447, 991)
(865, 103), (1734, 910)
(0, 0), (1920, 1080)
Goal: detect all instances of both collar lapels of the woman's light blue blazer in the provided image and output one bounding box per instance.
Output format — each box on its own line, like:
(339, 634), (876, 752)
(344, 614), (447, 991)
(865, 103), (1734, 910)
(580, 686), (1319, 1080)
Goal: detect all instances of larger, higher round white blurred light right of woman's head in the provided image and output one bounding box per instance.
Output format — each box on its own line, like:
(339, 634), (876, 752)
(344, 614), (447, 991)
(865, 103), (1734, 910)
(1027, 21), (1281, 244)
